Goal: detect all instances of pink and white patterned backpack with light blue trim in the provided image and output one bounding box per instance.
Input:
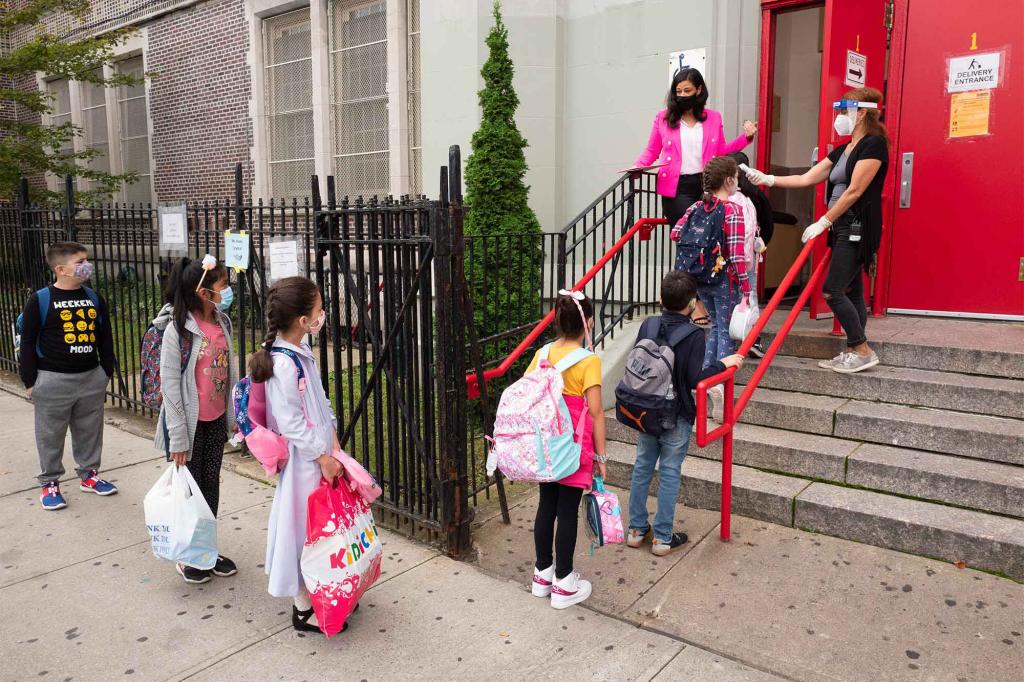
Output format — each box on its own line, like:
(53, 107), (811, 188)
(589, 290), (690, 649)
(486, 343), (594, 483)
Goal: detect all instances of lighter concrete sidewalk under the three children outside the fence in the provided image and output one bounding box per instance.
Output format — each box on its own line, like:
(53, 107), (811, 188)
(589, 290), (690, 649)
(0, 392), (778, 682)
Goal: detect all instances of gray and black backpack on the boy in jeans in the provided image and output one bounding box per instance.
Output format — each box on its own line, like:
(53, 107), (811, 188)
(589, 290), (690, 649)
(615, 316), (699, 436)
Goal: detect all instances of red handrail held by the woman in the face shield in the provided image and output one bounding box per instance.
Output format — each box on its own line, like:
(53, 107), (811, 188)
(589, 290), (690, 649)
(696, 236), (831, 542)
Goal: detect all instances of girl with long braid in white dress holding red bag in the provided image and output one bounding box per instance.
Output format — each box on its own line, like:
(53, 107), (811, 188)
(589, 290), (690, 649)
(249, 278), (348, 632)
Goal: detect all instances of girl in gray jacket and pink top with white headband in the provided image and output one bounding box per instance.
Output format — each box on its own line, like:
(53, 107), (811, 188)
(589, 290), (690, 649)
(153, 255), (238, 584)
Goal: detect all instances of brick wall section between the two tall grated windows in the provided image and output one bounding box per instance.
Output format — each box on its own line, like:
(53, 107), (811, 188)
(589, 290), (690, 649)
(146, 0), (253, 202)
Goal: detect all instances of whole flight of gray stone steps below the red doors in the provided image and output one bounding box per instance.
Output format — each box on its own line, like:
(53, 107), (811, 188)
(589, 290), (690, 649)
(605, 317), (1024, 581)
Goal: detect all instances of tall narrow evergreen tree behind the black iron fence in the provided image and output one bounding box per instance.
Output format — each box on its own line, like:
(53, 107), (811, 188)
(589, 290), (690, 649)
(465, 0), (544, 359)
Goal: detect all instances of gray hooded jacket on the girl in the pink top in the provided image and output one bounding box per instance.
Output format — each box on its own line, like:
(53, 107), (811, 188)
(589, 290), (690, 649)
(153, 304), (239, 460)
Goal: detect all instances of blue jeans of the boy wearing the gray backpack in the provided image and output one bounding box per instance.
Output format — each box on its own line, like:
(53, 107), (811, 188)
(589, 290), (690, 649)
(630, 418), (693, 541)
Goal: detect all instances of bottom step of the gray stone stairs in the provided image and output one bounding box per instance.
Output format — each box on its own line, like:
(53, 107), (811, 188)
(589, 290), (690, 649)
(608, 441), (1024, 581)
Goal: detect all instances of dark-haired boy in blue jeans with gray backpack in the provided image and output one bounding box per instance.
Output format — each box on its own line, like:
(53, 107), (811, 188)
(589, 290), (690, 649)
(615, 270), (743, 556)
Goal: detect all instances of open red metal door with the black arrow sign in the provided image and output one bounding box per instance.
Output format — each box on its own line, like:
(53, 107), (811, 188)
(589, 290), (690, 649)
(810, 0), (887, 317)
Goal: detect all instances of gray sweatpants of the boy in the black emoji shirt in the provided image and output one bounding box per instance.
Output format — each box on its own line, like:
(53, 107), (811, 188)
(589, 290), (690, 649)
(32, 367), (106, 485)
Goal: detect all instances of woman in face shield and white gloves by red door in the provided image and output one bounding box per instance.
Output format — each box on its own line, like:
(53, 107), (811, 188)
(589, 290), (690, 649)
(746, 88), (889, 374)
